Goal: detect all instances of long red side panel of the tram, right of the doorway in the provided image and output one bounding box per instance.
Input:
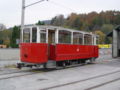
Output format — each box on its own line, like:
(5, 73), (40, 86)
(50, 44), (98, 61)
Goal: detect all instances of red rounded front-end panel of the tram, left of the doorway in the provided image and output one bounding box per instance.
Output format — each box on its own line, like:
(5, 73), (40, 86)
(20, 43), (48, 64)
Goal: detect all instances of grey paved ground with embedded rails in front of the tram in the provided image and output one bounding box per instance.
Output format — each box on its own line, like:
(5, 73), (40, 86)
(0, 49), (120, 90)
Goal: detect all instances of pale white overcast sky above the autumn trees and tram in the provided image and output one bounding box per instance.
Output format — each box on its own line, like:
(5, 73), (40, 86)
(0, 0), (120, 27)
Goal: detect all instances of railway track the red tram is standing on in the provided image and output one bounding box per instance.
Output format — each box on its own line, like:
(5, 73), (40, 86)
(0, 64), (90, 80)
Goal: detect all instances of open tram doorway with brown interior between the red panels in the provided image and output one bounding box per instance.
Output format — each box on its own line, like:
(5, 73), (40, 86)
(48, 30), (55, 57)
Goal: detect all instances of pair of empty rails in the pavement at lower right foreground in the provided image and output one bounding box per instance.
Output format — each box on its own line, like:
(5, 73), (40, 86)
(39, 70), (120, 90)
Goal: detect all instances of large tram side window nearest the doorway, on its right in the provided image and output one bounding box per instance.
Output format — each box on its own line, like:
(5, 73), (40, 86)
(59, 30), (71, 44)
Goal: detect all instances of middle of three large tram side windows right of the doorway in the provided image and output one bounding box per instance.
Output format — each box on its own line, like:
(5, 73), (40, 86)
(73, 32), (83, 44)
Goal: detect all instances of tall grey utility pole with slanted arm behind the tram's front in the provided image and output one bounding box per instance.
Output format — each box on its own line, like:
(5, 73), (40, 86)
(20, 0), (48, 42)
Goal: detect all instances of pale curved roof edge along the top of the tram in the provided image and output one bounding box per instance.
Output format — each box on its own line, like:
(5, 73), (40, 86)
(24, 25), (98, 36)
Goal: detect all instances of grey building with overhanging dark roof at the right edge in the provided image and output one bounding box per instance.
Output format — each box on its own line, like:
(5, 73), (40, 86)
(107, 25), (120, 58)
